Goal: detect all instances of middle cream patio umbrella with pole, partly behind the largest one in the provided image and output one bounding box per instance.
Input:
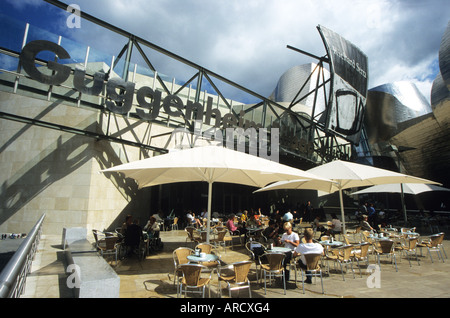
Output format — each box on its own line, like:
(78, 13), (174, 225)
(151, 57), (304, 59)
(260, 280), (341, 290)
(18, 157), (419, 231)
(307, 160), (438, 234)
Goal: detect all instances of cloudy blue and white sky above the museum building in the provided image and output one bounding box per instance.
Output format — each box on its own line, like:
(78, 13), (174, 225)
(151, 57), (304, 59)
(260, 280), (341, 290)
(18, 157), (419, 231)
(0, 0), (450, 100)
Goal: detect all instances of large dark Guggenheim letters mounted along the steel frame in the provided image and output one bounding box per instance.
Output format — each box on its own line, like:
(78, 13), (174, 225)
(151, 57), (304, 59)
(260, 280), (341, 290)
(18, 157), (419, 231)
(20, 40), (262, 129)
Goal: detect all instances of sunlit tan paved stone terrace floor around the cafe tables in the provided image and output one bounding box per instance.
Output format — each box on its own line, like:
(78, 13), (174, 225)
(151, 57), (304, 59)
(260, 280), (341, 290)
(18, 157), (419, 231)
(22, 230), (450, 299)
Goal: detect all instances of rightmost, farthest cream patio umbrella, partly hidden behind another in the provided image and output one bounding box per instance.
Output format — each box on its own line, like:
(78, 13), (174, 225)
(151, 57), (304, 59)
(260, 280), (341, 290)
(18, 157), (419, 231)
(352, 183), (450, 223)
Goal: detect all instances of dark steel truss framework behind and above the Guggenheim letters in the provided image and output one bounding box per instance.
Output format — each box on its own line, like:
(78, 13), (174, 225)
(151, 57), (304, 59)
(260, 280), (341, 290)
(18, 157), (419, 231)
(0, 0), (354, 165)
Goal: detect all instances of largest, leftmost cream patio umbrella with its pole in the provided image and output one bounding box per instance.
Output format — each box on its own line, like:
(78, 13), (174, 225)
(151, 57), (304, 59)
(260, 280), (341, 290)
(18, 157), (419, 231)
(101, 146), (329, 242)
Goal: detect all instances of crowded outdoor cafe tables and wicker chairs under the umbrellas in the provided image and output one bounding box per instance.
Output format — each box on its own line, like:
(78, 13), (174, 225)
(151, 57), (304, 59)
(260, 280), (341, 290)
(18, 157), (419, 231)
(88, 217), (447, 298)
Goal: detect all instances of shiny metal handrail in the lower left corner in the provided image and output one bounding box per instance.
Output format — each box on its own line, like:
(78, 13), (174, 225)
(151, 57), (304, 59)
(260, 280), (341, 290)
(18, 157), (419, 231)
(0, 214), (45, 298)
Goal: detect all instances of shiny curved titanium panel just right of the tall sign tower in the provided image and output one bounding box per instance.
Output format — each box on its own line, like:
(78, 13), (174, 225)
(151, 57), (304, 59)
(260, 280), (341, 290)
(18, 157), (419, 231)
(364, 82), (432, 143)
